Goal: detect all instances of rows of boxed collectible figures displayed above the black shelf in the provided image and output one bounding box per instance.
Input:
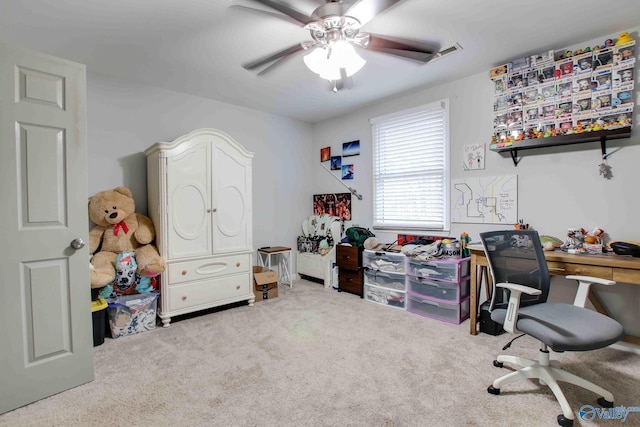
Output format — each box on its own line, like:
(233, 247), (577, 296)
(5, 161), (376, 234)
(489, 40), (636, 144)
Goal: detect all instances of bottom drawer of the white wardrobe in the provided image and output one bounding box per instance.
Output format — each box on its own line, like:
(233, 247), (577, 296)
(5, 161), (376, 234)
(161, 273), (252, 311)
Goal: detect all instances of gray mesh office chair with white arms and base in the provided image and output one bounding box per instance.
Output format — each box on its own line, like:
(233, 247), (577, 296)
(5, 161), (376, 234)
(480, 230), (623, 427)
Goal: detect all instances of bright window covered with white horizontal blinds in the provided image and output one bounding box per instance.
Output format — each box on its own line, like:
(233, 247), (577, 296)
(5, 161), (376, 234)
(371, 100), (449, 230)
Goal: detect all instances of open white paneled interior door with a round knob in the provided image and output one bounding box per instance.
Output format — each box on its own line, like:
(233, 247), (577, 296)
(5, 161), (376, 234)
(0, 43), (93, 413)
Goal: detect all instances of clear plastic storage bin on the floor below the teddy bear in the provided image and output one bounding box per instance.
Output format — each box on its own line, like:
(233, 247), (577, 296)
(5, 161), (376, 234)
(107, 292), (159, 338)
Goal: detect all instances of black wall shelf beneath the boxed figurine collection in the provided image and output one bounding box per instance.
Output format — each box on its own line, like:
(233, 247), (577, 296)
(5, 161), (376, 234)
(490, 126), (631, 166)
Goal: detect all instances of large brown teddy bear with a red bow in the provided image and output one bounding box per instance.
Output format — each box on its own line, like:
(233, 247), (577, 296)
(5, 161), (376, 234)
(89, 187), (166, 288)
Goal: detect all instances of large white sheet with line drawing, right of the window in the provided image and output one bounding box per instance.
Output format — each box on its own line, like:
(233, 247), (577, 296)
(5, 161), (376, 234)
(451, 175), (518, 224)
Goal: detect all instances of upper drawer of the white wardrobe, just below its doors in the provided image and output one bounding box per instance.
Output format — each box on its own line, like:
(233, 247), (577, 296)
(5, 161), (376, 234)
(167, 254), (251, 285)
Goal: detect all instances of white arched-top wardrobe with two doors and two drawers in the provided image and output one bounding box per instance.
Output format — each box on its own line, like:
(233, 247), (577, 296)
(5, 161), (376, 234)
(145, 129), (255, 327)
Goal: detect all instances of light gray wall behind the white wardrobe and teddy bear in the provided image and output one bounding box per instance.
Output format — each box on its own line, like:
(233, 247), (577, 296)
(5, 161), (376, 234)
(87, 73), (316, 254)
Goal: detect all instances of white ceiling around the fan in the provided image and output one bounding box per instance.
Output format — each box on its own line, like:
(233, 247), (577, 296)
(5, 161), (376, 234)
(0, 0), (640, 122)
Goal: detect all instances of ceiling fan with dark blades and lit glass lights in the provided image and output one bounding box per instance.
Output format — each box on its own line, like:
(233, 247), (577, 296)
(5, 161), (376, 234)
(237, 0), (439, 92)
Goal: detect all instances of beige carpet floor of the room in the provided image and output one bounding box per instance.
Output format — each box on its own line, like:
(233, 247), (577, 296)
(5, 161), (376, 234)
(0, 280), (640, 427)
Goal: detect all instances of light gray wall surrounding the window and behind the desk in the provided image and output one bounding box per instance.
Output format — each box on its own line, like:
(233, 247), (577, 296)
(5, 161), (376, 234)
(312, 27), (640, 336)
